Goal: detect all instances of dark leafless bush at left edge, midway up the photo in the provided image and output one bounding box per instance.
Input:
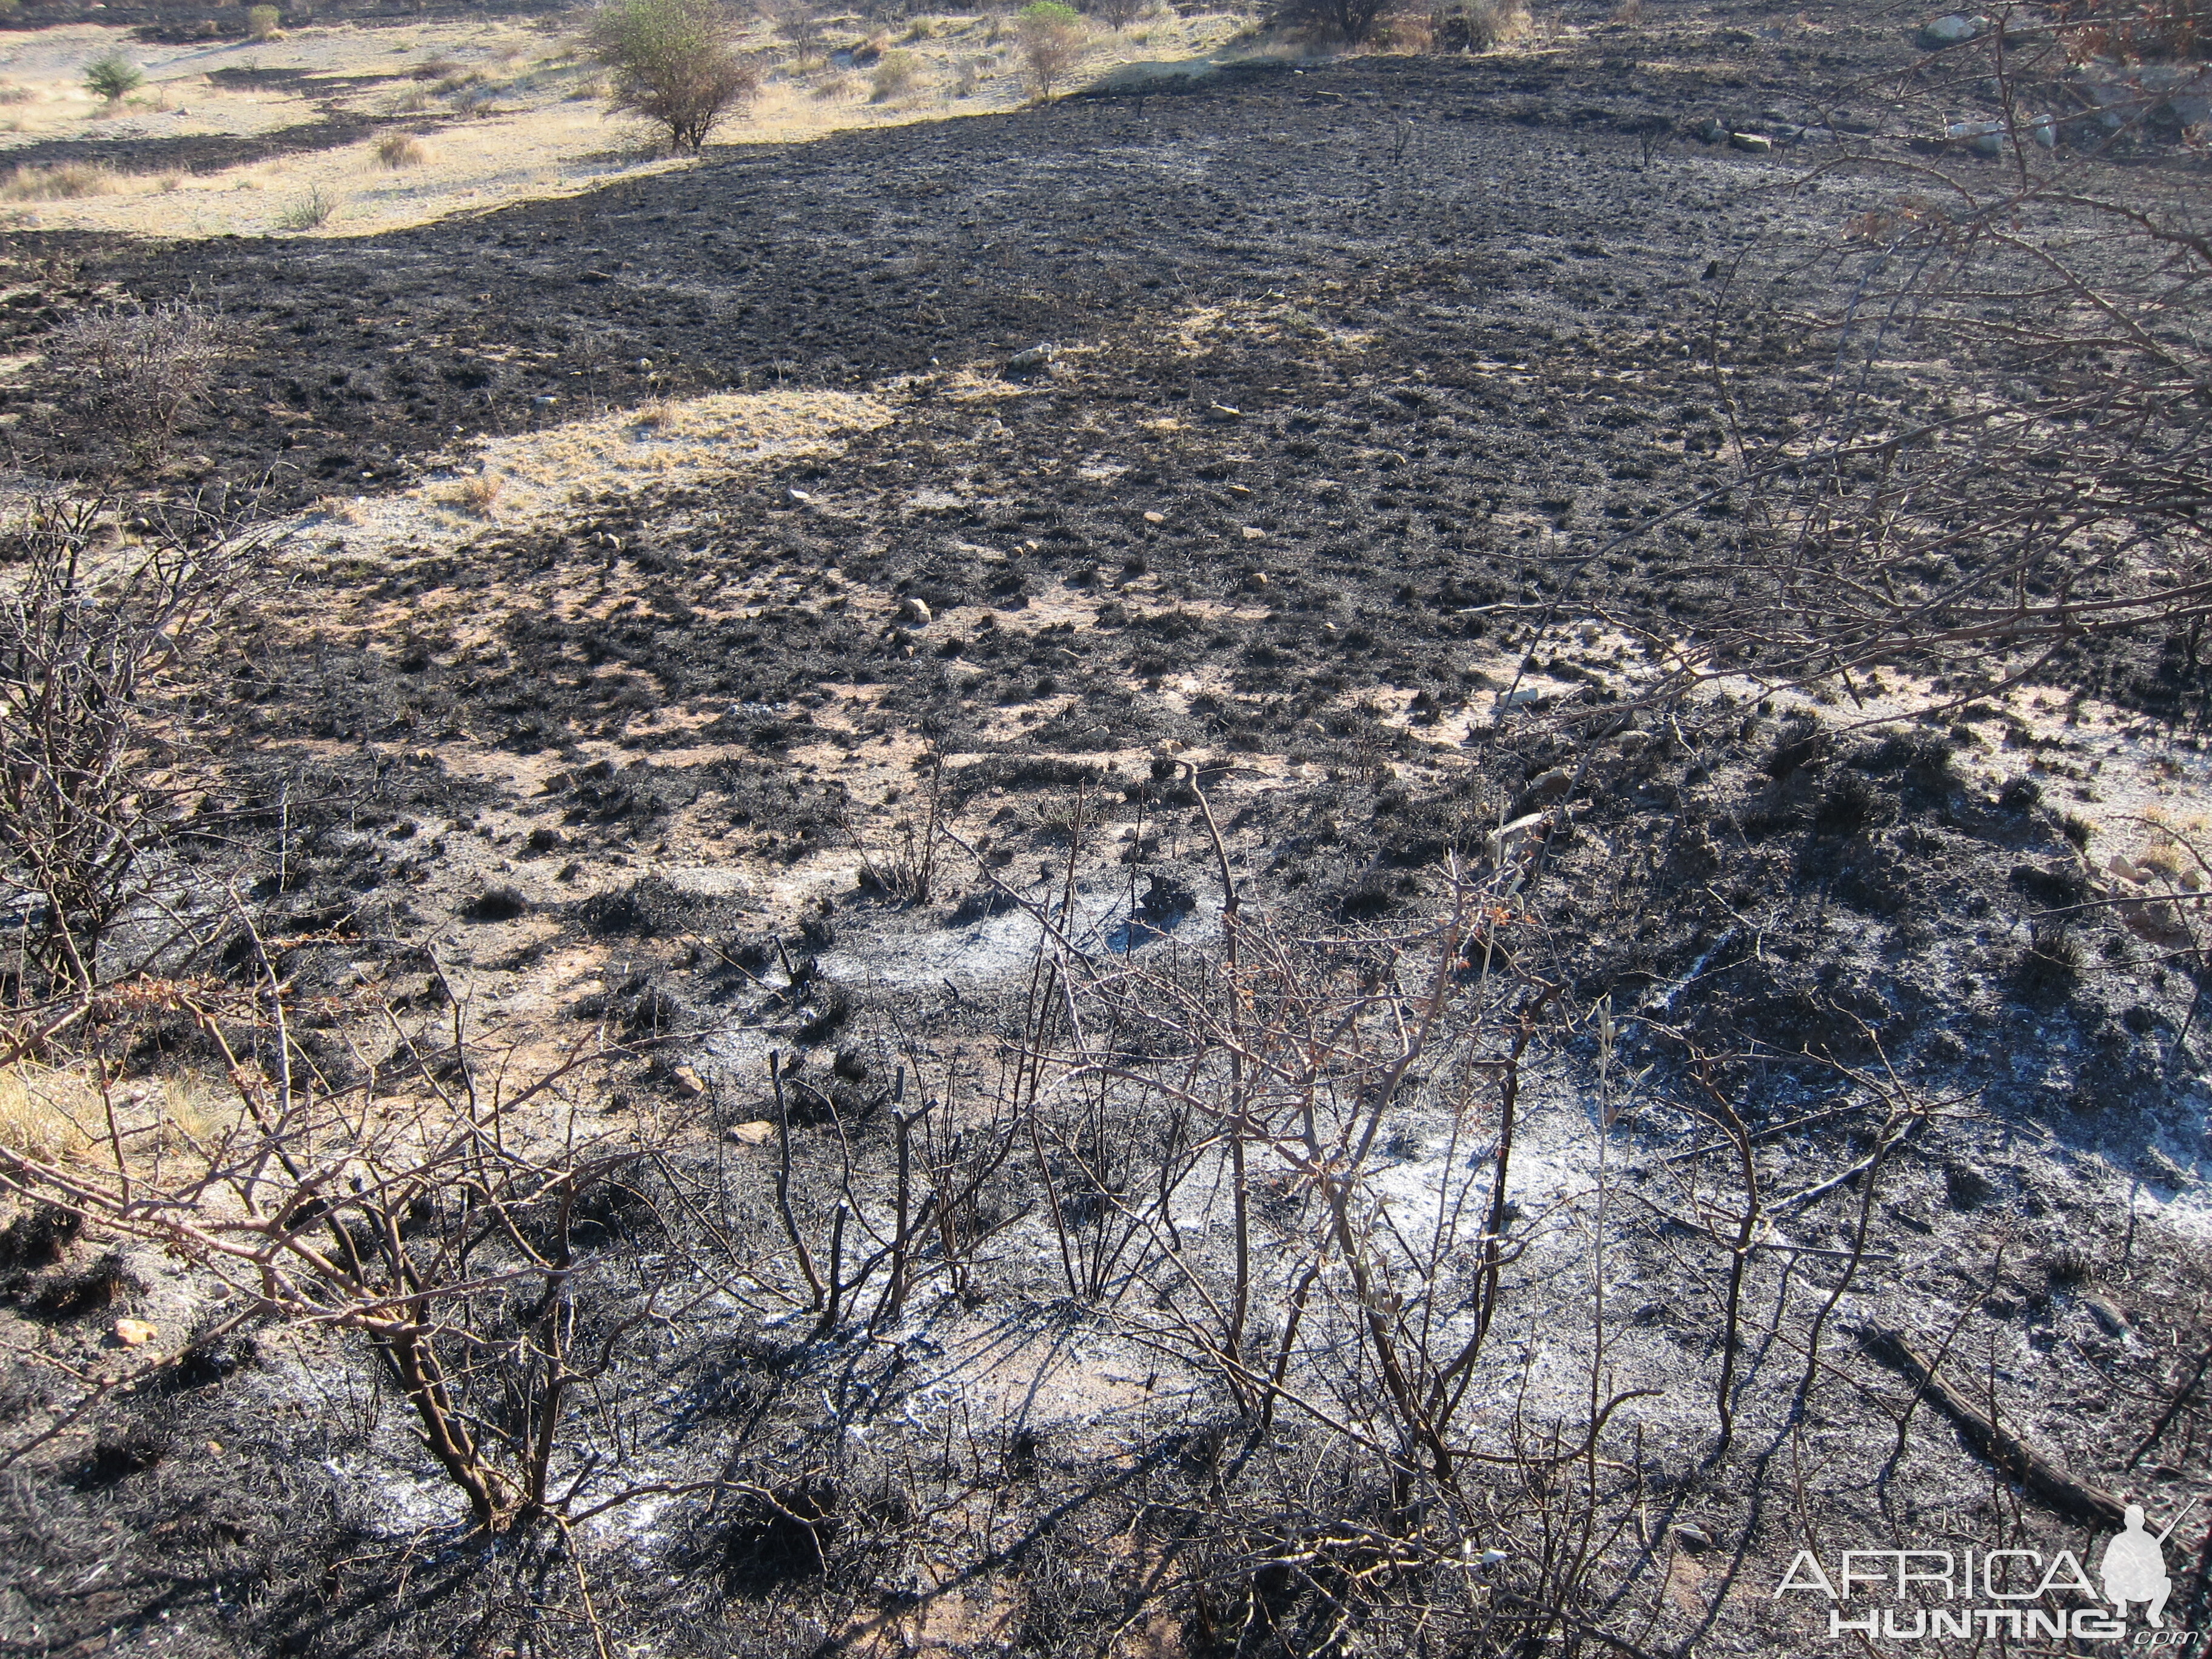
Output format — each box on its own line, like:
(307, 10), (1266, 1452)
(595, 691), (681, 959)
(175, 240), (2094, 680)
(0, 502), (261, 1002)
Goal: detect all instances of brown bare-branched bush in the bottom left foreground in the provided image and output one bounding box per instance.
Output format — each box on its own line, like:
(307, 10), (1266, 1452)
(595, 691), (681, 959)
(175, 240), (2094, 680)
(0, 960), (712, 1548)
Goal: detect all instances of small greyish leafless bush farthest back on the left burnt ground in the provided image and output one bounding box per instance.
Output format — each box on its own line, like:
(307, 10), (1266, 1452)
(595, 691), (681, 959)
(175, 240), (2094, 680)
(53, 301), (246, 462)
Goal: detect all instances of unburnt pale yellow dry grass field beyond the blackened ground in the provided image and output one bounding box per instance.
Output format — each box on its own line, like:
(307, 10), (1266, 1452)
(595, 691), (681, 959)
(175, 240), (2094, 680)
(0, 13), (1245, 239)
